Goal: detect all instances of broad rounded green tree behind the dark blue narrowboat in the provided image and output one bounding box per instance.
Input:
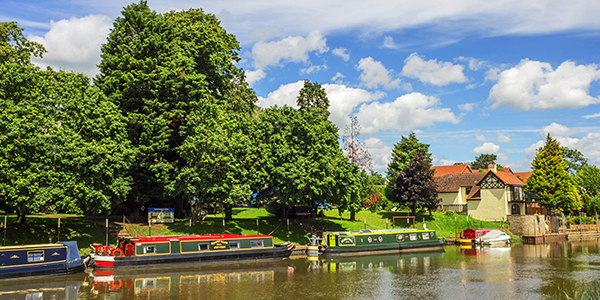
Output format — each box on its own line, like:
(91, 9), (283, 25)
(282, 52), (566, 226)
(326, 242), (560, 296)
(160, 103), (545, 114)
(0, 64), (132, 222)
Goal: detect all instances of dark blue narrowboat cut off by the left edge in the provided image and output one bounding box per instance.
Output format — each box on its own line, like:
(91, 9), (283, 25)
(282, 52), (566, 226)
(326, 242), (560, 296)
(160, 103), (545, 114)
(0, 242), (90, 278)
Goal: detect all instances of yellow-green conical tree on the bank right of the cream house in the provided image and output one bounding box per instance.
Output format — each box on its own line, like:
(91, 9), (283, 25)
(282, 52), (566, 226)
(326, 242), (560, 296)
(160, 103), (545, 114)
(525, 134), (581, 211)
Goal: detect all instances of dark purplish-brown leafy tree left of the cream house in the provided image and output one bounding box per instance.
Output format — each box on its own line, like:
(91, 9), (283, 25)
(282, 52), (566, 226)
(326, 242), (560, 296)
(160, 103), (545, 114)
(388, 149), (441, 215)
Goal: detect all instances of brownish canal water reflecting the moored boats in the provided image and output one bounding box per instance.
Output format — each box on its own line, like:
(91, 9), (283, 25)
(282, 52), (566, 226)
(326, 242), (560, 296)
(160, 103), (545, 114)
(0, 240), (600, 300)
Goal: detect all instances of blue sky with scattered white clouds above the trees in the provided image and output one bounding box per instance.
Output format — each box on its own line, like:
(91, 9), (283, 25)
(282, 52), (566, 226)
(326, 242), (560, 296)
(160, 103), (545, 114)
(0, 0), (600, 174)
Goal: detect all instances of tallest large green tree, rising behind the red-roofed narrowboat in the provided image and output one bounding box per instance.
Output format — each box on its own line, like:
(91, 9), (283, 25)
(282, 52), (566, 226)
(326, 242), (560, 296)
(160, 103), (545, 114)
(96, 1), (256, 219)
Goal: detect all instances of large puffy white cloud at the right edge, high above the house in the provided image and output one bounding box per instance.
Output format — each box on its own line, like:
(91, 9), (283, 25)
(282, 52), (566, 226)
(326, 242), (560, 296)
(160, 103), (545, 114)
(489, 59), (600, 110)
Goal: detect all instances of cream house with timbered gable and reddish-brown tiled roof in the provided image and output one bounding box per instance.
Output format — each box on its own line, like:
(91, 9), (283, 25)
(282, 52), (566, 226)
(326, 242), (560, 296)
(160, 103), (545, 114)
(433, 163), (526, 220)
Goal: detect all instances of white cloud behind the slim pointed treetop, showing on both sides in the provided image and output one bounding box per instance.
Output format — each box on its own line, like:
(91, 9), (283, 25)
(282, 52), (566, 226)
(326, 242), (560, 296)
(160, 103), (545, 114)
(258, 80), (384, 130)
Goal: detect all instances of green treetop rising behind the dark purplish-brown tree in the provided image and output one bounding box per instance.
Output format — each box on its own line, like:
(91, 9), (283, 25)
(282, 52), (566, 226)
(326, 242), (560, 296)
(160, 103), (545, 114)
(387, 132), (431, 177)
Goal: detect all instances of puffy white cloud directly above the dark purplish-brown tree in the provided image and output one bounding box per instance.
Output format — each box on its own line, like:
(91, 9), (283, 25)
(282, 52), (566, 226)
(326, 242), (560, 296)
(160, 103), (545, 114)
(357, 93), (459, 134)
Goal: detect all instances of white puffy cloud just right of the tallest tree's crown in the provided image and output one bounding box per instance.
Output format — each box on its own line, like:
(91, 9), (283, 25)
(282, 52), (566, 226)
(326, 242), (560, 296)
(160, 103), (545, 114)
(252, 30), (329, 69)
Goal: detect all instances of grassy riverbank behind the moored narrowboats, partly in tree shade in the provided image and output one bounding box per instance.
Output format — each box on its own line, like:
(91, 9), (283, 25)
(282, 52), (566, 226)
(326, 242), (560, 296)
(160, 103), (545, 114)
(1, 207), (515, 253)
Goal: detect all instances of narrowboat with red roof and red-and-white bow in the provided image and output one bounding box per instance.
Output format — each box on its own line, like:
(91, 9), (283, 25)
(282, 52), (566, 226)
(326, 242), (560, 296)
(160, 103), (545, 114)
(92, 234), (294, 269)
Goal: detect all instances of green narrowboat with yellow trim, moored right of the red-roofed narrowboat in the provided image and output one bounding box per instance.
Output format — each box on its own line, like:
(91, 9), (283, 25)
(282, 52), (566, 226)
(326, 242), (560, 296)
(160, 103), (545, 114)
(320, 228), (444, 256)
